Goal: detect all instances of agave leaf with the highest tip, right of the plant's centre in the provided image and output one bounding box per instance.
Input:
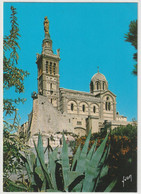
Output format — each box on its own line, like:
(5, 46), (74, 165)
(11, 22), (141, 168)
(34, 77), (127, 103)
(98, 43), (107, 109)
(72, 131), (91, 192)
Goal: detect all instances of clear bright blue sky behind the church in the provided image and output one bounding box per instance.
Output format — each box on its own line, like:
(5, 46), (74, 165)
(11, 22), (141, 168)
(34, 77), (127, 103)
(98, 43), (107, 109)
(4, 3), (137, 124)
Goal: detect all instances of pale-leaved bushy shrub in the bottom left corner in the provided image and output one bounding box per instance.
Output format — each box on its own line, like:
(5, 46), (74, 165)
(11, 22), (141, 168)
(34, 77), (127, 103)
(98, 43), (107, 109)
(3, 124), (28, 192)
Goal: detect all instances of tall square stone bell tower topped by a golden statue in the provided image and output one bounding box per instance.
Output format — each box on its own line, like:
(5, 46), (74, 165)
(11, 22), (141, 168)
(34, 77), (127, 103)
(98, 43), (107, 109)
(36, 16), (60, 109)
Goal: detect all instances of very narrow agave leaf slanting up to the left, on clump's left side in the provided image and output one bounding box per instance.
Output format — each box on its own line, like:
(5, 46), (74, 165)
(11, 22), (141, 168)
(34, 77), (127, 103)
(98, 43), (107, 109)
(33, 141), (53, 189)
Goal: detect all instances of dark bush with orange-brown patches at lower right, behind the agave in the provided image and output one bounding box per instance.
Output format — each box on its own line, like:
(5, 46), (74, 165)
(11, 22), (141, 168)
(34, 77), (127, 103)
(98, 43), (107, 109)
(78, 125), (137, 192)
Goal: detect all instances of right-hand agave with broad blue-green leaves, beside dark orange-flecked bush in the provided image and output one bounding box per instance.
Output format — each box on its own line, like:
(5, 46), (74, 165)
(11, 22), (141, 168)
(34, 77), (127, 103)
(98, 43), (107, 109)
(62, 132), (116, 192)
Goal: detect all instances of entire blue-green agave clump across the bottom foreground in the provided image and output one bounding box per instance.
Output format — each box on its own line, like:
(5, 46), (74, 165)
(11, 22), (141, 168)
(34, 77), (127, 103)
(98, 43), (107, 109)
(7, 132), (116, 192)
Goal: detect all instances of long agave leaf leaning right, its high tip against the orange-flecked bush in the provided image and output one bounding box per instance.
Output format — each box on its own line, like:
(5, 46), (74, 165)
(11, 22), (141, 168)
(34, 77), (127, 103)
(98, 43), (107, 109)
(82, 135), (108, 192)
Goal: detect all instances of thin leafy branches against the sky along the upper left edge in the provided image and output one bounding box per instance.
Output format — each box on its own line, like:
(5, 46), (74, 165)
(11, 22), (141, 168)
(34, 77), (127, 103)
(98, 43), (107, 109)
(3, 6), (29, 115)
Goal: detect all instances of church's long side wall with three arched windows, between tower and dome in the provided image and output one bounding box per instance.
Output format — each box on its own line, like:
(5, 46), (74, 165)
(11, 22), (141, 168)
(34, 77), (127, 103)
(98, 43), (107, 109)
(60, 88), (101, 117)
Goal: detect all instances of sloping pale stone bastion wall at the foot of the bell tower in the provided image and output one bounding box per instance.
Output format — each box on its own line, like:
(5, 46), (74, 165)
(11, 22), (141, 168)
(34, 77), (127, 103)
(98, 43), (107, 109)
(30, 95), (73, 136)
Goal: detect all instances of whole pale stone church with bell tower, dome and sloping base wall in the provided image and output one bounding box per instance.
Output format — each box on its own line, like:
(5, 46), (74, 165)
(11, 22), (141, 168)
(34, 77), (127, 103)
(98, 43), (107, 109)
(21, 17), (129, 146)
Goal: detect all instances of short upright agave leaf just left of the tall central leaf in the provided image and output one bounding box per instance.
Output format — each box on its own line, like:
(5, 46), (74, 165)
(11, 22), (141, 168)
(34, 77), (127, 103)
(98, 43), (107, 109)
(48, 148), (58, 189)
